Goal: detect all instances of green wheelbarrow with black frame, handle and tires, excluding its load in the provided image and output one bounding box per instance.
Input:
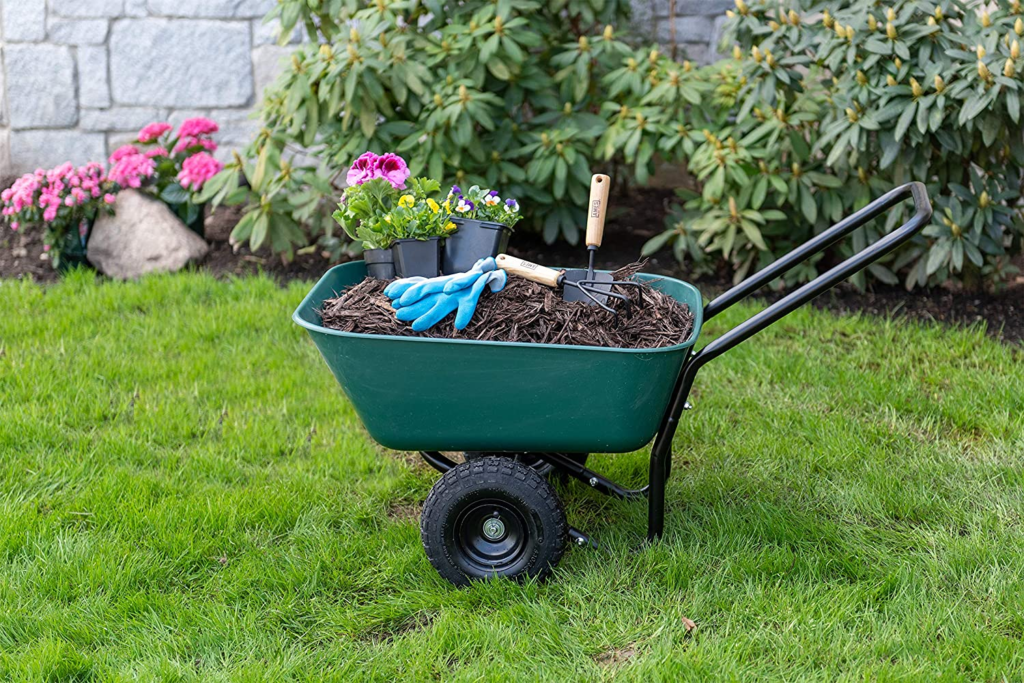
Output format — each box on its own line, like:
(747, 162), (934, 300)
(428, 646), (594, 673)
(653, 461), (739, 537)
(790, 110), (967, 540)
(292, 182), (932, 586)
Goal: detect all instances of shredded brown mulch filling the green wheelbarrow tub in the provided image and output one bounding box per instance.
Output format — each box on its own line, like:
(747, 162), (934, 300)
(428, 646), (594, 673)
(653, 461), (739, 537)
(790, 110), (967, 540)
(319, 263), (693, 348)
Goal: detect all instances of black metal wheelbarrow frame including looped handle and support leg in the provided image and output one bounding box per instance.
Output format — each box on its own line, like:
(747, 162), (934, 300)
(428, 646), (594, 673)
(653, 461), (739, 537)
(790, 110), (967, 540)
(421, 182), (932, 545)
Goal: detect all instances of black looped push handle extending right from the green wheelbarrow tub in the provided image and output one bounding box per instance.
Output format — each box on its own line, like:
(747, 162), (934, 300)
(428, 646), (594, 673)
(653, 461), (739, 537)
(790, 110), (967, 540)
(688, 182), (932, 366)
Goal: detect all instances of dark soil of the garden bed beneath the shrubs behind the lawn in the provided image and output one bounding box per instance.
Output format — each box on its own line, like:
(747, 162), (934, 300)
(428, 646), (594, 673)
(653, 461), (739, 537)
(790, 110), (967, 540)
(0, 182), (1024, 342)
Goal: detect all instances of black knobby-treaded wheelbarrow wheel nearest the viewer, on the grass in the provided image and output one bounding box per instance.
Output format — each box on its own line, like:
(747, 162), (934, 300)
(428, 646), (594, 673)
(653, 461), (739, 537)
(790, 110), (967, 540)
(420, 456), (568, 587)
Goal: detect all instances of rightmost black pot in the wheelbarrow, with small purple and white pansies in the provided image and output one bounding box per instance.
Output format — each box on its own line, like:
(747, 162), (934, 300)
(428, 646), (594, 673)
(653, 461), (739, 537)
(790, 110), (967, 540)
(442, 185), (521, 272)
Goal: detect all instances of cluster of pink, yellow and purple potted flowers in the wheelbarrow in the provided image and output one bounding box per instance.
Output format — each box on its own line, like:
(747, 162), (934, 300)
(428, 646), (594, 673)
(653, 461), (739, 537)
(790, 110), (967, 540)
(334, 152), (519, 280)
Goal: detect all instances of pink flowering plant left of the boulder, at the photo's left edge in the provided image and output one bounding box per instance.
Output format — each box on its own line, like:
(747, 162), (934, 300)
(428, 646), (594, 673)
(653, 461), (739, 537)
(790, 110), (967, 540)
(0, 162), (116, 268)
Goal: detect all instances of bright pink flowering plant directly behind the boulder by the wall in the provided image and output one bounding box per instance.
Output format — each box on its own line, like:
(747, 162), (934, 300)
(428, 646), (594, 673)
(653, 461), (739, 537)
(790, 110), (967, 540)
(109, 117), (223, 232)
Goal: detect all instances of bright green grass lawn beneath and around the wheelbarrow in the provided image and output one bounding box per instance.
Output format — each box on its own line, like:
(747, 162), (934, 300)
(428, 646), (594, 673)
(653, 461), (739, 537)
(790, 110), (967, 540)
(0, 273), (1024, 681)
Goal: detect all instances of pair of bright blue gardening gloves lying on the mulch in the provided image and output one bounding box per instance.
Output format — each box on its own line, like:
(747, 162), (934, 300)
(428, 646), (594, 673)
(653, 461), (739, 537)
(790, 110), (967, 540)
(384, 257), (508, 332)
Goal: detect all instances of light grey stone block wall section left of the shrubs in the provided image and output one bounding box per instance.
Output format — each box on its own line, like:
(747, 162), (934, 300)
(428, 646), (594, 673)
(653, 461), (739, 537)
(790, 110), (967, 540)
(0, 0), (290, 175)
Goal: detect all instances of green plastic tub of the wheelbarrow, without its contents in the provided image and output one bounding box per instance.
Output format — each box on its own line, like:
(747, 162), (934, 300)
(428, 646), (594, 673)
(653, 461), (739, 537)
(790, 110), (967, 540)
(292, 261), (702, 453)
